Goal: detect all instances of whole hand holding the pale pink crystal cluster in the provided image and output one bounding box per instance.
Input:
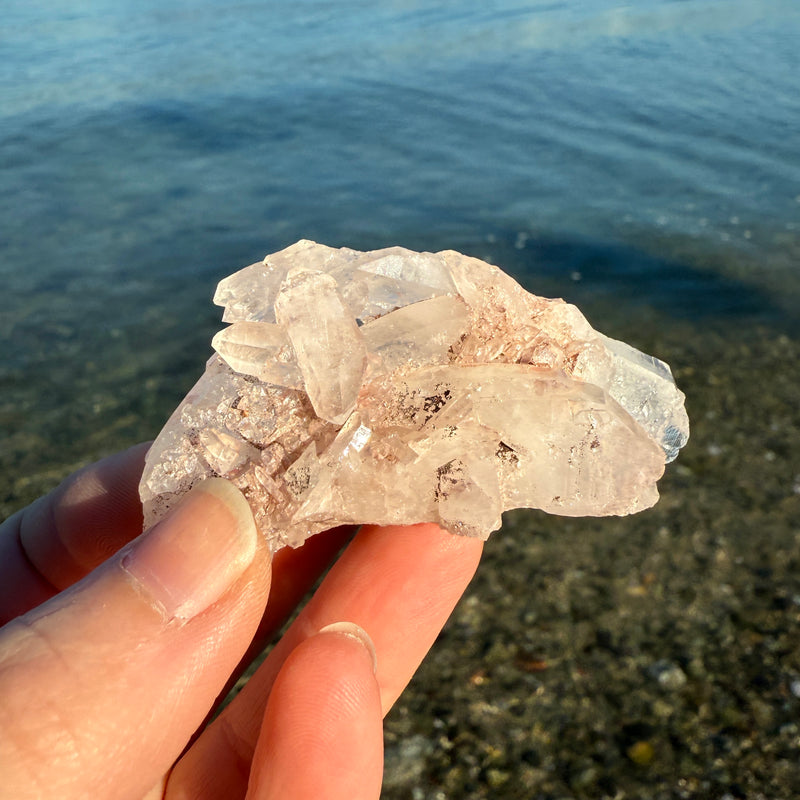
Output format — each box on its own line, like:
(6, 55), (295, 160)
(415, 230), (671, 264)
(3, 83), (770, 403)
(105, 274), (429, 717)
(0, 446), (481, 800)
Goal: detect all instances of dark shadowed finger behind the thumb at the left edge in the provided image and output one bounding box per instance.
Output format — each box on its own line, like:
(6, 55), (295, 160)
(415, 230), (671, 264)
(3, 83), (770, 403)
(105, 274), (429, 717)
(0, 444), (149, 624)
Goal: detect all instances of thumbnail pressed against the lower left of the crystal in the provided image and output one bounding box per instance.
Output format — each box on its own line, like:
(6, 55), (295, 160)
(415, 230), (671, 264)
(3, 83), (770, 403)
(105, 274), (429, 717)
(122, 478), (257, 620)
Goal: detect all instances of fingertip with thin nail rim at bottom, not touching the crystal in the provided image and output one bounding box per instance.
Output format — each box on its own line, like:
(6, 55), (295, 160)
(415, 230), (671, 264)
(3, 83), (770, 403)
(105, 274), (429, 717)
(247, 623), (383, 800)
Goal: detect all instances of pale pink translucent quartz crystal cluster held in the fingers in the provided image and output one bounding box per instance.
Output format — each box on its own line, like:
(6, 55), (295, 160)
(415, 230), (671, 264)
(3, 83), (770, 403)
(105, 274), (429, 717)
(140, 240), (689, 550)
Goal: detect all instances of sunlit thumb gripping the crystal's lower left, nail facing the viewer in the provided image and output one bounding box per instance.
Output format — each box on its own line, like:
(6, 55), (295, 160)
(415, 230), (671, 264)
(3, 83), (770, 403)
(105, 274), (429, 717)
(0, 479), (269, 800)
